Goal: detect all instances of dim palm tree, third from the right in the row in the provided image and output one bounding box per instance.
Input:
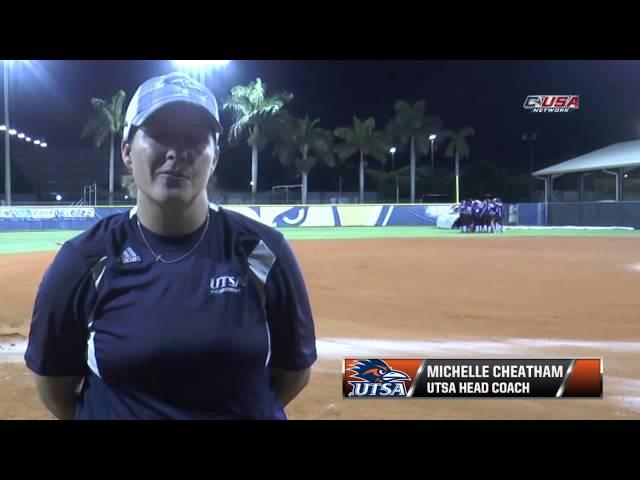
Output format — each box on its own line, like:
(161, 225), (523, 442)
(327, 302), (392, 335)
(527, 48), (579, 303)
(334, 116), (389, 203)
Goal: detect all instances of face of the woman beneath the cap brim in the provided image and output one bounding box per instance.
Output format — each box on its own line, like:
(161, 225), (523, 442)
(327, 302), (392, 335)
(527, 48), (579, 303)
(122, 103), (218, 206)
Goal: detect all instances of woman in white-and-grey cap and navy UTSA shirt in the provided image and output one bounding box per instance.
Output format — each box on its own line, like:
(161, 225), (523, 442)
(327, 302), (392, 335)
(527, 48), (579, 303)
(25, 73), (316, 419)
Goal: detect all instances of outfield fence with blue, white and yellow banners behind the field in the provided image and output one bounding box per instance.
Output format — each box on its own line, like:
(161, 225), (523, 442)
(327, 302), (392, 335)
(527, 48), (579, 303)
(0, 202), (640, 231)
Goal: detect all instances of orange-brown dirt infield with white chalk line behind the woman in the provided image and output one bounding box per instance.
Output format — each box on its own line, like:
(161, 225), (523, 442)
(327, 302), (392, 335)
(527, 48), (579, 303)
(0, 238), (640, 419)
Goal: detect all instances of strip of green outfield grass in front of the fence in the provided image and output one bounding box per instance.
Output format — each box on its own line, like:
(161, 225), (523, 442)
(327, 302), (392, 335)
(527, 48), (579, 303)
(0, 227), (640, 254)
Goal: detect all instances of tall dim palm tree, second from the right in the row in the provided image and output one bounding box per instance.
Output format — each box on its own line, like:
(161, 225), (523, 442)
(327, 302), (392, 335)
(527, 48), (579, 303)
(387, 100), (442, 203)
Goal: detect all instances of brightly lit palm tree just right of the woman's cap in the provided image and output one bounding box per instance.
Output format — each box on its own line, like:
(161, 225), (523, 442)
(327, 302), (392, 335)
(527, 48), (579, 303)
(222, 78), (293, 194)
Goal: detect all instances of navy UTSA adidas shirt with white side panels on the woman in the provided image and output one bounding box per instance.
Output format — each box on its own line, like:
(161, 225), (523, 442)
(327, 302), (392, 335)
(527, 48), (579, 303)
(25, 205), (317, 419)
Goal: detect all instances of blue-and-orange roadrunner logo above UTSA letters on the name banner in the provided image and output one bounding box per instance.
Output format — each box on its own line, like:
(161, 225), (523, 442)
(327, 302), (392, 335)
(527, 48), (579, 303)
(346, 359), (411, 397)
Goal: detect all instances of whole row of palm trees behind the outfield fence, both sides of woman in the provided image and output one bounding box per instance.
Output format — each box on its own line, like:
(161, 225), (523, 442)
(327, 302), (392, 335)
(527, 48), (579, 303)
(81, 78), (498, 204)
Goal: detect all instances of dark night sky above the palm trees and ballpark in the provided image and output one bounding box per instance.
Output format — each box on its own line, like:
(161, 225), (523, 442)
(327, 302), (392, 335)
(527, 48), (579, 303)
(5, 60), (640, 190)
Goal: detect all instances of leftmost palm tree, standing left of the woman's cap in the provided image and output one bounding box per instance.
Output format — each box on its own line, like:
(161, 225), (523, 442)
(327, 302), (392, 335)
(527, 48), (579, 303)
(82, 90), (127, 205)
